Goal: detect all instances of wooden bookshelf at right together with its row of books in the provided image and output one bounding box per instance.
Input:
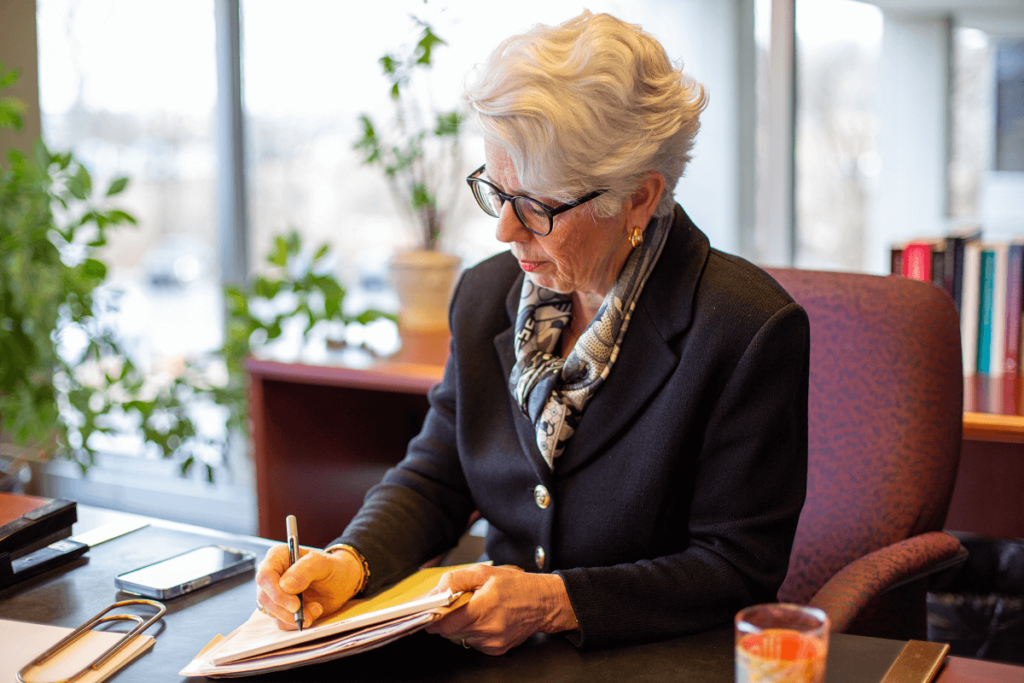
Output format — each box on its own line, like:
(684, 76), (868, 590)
(891, 232), (1024, 538)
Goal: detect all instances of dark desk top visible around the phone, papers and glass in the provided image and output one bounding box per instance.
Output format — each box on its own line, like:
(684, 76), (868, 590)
(0, 508), (1024, 683)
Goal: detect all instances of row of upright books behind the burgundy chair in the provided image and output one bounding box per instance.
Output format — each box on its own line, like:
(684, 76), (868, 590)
(891, 228), (1024, 377)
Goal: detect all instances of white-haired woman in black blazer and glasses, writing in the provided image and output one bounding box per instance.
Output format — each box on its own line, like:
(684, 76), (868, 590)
(257, 12), (809, 654)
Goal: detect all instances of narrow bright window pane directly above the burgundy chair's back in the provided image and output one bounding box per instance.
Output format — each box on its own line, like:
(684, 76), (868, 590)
(794, 0), (882, 270)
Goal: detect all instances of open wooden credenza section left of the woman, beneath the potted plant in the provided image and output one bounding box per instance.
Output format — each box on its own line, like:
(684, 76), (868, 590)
(248, 332), (449, 548)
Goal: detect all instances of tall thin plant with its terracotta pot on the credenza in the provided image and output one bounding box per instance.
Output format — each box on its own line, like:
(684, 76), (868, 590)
(355, 19), (463, 333)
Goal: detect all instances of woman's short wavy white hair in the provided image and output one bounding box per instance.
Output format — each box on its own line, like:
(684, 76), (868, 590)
(463, 10), (708, 216)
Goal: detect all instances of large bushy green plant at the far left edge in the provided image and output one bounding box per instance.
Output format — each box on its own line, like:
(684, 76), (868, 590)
(0, 65), (212, 477)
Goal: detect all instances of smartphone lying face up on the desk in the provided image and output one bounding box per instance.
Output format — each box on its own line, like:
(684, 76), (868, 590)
(114, 546), (256, 599)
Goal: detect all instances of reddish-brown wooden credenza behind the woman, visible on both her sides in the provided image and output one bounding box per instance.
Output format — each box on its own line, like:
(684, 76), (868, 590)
(248, 333), (1024, 547)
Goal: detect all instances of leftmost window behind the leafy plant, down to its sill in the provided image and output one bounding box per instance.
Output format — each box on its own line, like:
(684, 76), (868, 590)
(37, 0), (255, 532)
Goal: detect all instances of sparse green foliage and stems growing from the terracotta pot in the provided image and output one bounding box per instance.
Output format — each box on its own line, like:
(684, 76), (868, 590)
(355, 17), (462, 249)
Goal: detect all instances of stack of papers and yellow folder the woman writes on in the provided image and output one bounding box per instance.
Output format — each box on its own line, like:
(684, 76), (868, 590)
(179, 567), (479, 678)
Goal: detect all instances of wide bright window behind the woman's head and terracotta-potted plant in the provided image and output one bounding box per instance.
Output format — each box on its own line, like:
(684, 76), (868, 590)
(242, 0), (736, 284)
